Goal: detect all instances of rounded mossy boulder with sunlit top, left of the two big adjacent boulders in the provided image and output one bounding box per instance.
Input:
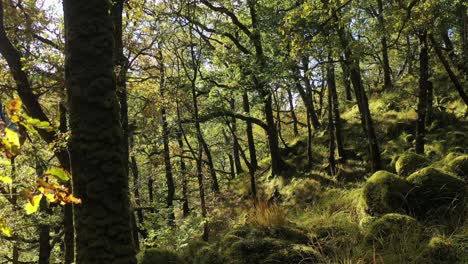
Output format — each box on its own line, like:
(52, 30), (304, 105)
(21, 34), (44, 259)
(362, 171), (412, 215)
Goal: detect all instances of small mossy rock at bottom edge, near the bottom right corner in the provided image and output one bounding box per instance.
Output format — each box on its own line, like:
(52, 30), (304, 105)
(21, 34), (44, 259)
(417, 236), (459, 264)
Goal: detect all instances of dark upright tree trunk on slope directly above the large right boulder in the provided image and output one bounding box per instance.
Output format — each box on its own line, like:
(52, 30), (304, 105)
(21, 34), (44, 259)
(414, 31), (429, 154)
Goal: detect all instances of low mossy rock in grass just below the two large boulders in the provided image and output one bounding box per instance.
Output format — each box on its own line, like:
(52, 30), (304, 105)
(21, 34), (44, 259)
(365, 213), (423, 246)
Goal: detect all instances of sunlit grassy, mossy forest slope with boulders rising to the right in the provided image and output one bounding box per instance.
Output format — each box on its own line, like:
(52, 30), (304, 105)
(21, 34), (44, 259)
(140, 92), (468, 264)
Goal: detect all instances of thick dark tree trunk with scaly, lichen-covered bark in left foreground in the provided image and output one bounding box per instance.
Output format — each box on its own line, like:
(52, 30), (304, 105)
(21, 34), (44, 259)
(63, 0), (136, 264)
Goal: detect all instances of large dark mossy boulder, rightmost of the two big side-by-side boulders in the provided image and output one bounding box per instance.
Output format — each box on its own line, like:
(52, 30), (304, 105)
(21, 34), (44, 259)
(408, 167), (466, 218)
